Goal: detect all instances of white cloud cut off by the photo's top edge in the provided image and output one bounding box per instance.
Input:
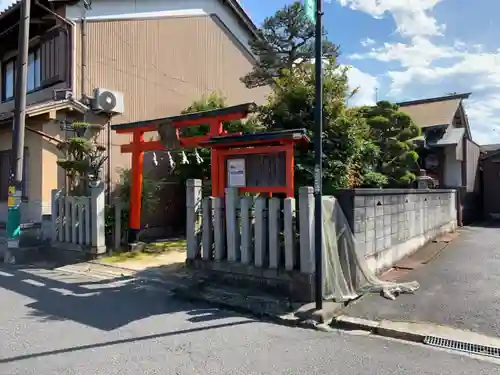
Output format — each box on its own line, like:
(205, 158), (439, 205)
(337, 0), (445, 37)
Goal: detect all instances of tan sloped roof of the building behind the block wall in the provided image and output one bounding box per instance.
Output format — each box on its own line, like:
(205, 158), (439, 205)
(398, 93), (470, 128)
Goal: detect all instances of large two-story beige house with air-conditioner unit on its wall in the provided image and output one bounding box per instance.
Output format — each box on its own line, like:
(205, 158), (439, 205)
(0, 0), (268, 221)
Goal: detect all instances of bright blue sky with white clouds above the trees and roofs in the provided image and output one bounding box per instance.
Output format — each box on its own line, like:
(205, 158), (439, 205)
(240, 0), (500, 144)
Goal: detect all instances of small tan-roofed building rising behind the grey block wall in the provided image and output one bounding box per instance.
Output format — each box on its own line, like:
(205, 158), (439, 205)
(398, 93), (481, 225)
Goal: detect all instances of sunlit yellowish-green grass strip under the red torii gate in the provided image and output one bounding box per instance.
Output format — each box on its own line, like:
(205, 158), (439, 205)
(101, 239), (186, 263)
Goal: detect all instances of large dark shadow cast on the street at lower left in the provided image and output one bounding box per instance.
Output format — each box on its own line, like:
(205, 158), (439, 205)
(0, 266), (244, 332)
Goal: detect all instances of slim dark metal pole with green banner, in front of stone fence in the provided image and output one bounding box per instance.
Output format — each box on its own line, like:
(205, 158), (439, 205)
(304, 0), (323, 310)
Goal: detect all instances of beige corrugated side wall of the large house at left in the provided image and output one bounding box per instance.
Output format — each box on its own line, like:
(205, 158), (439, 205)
(71, 16), (269, 188)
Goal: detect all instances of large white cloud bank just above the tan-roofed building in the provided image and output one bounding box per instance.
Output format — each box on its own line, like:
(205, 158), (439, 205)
(368, 38), (500, 143)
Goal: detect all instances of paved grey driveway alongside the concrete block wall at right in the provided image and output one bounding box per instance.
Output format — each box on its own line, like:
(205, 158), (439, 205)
(345, 223), (500, 337)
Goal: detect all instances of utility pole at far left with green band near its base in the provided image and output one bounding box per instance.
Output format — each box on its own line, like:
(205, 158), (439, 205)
(6, 0), (31, 260)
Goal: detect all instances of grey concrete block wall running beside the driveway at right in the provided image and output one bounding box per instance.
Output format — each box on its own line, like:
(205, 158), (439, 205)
(336, 189), (457, 273)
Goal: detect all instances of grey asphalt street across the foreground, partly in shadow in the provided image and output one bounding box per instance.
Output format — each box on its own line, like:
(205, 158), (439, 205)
(0, 266), (500, 375)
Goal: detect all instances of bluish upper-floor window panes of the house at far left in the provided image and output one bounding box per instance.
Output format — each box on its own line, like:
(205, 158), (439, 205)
(2, 48), (41, 101)
